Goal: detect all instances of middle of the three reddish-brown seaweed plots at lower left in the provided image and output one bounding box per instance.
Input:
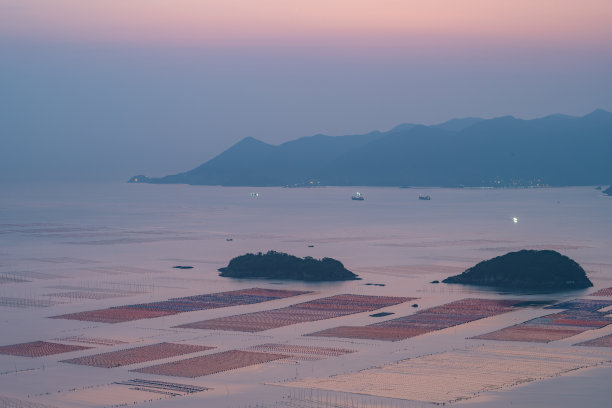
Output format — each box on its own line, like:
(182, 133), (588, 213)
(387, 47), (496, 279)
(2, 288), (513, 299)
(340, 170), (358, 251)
(61, 343), (214, 368)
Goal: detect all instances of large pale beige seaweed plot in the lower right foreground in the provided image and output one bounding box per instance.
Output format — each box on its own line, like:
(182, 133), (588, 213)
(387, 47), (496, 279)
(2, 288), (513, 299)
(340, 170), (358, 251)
(275, 347), (611, 404)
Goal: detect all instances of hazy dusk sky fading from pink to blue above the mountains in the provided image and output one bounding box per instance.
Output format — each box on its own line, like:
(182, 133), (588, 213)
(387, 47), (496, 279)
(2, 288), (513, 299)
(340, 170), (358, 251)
(0, 0), (612, 183)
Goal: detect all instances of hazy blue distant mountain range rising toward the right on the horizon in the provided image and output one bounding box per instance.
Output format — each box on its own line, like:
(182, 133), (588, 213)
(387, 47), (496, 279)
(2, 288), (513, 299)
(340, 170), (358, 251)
(130, 109), (612, 187)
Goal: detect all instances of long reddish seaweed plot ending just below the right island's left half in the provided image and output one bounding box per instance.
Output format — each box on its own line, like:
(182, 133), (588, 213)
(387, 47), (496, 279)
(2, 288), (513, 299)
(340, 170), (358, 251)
(307, 299), (519, 341)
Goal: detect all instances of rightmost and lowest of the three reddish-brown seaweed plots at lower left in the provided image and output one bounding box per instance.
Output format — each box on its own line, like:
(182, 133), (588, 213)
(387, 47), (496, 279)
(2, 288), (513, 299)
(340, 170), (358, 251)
(132, 350), (287, 378)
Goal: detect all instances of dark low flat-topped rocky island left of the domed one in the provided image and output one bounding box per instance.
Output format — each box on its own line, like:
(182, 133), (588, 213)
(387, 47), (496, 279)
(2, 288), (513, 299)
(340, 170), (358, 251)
(219, 251), (360, 282)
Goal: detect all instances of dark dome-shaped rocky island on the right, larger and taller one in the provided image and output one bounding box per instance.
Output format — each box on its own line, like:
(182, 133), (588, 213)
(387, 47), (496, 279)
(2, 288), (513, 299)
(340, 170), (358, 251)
(443, 249), (593, 291)
